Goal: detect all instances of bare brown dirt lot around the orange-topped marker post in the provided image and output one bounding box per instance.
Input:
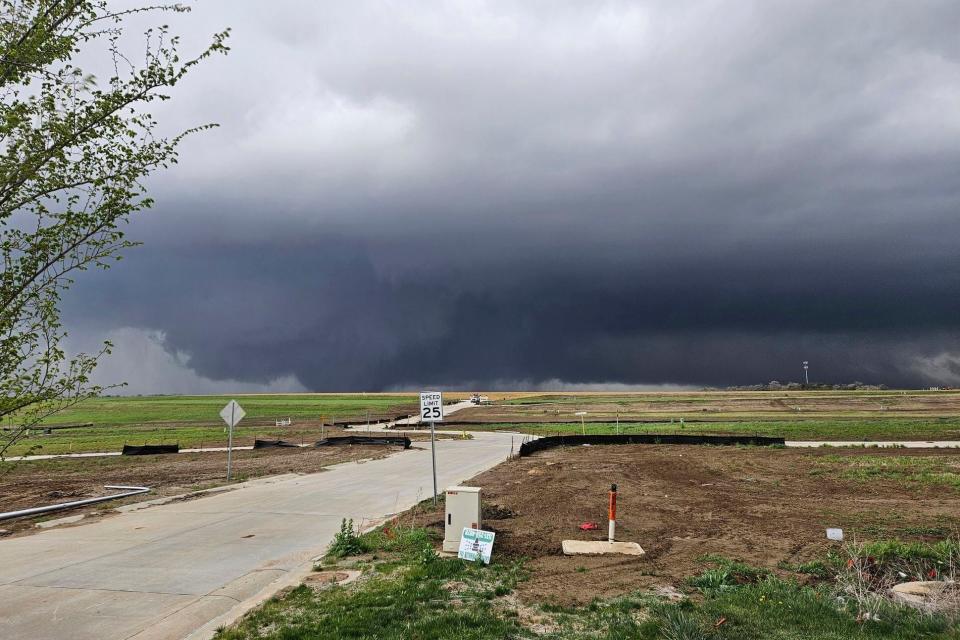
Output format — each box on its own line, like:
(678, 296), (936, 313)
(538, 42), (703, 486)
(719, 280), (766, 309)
(406, 445), (960, 605)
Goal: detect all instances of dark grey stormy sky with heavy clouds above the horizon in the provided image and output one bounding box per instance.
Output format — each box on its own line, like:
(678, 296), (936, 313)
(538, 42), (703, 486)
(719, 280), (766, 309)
(67, 0), (960, 393)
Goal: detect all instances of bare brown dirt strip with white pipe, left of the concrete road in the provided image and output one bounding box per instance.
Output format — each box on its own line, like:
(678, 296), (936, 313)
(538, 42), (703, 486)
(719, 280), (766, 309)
(0, 445), (402, 533)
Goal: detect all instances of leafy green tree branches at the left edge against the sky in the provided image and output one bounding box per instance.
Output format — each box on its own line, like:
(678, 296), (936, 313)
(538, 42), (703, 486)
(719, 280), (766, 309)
(0, 0), (228, 457)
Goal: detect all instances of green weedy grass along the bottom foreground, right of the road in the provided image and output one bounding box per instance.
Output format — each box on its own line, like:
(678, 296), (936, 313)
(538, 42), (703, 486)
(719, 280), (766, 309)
(217, 532), (960, 640)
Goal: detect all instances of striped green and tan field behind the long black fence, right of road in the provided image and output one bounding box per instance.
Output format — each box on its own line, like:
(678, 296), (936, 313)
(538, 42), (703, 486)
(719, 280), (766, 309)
(451, 391), (960, 440)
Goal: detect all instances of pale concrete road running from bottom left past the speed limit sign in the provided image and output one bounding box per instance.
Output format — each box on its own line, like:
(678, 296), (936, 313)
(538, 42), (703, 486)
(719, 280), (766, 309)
(0, 420), (519, 640)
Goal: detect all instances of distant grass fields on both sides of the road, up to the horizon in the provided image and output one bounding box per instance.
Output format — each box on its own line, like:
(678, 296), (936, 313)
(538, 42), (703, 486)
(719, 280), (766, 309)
(7, 391), (960, 456)
